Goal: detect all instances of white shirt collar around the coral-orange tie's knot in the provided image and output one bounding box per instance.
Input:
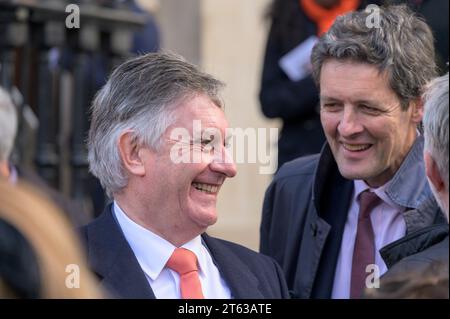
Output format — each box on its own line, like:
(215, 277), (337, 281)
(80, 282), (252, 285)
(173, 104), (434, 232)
(114, 201), (206, 280)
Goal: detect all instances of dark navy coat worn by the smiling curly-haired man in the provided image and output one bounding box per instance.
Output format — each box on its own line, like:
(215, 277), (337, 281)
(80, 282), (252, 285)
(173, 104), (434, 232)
(260, 137), (446, 298)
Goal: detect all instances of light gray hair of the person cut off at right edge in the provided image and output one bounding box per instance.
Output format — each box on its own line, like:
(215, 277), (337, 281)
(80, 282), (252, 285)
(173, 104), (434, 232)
(423, 73), (449, 191)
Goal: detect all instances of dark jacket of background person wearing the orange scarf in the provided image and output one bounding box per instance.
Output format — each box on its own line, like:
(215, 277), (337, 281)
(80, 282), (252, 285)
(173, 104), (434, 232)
(259, 0), (325, 167)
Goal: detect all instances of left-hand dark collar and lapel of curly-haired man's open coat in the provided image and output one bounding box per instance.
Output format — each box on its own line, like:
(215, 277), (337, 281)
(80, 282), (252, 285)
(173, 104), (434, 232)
(294, 144), (353, 298)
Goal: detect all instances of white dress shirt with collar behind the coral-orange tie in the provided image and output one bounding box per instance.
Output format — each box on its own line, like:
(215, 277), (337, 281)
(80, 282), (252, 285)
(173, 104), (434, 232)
(114, 202), (231, 299)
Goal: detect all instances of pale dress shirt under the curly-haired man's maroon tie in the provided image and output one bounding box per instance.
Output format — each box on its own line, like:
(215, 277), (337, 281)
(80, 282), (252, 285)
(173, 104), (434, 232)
(331, 180), (406, 299)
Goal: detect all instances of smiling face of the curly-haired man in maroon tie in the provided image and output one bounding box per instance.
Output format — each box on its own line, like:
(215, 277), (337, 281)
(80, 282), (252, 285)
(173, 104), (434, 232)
(320, 59), (422, 187)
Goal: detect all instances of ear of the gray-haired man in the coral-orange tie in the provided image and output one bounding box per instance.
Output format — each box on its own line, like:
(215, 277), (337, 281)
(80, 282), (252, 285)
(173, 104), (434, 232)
(118, 130), (145, 176)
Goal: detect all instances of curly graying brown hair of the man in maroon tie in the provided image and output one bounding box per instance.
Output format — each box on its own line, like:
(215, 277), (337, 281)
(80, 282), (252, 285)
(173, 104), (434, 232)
(311, 5), (437, 110)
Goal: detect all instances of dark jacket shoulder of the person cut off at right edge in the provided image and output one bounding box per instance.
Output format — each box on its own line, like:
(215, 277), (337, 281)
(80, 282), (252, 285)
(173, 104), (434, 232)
(380, 198), (449, 277)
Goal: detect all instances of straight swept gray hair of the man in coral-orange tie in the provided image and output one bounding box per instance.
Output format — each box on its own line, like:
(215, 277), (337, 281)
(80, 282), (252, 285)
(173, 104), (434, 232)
(88, 53), (223, 196)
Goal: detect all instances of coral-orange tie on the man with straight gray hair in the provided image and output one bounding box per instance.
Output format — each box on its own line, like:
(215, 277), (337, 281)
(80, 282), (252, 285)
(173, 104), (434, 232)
(166, 248), (205, 299)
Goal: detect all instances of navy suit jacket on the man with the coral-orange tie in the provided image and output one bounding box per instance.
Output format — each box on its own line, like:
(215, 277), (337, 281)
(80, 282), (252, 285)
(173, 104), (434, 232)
(80, 205), (289, 299)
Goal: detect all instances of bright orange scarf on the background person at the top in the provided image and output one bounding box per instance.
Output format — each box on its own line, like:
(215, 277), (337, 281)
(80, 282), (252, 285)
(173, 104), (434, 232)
(300, 0), (361, 36)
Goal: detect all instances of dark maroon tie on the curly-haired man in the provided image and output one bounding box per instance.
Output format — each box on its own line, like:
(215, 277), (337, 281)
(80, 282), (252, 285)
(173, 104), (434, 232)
(350, 191), (380, 299)
